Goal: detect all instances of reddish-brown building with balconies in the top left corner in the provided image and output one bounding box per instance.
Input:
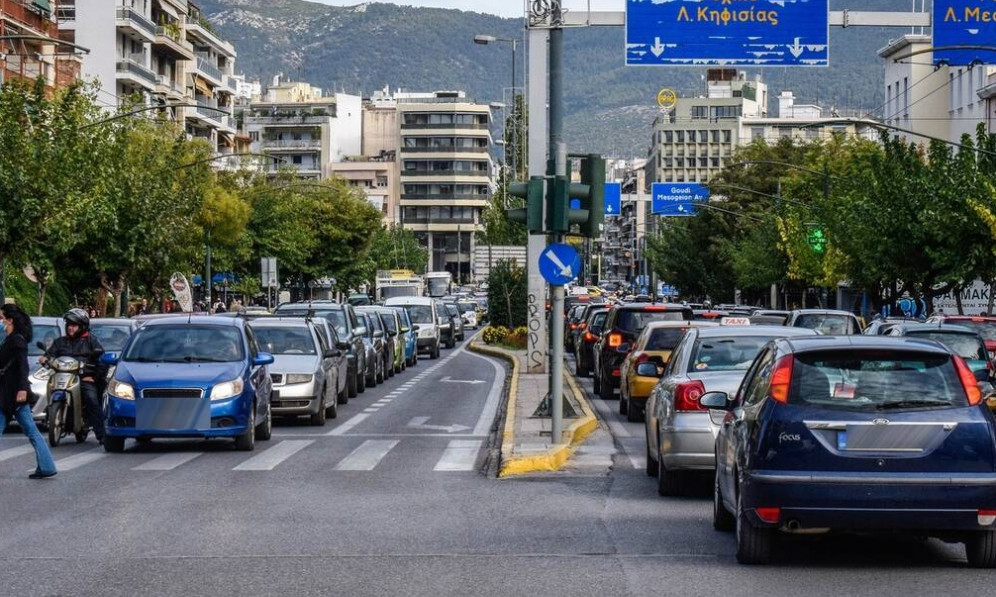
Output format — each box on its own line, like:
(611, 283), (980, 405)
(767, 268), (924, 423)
(0, 0), (80, 88)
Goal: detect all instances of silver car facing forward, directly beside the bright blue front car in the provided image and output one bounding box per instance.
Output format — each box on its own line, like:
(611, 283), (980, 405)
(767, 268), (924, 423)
(249, 318), (339, 426)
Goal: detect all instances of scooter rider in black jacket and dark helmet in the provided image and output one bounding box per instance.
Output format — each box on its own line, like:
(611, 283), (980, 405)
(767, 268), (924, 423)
(38, 309), (107, 444)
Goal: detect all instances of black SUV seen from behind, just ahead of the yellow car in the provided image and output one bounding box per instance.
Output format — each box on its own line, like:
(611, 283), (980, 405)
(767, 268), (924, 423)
(592, 303), (692, 400)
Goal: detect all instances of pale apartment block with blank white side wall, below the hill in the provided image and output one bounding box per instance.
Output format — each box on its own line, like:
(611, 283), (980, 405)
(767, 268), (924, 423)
(245, 76), (363, 180)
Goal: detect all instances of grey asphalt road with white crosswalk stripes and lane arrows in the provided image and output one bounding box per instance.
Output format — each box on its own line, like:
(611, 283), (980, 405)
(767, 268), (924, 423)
(0, 340), (996, 597)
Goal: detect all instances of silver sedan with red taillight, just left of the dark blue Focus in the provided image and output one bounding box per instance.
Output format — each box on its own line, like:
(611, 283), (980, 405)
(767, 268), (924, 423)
(639, 325), (819, 495)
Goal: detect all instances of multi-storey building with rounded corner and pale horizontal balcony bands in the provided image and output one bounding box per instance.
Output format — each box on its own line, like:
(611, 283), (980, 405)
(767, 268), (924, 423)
(393, 91), (493, 282)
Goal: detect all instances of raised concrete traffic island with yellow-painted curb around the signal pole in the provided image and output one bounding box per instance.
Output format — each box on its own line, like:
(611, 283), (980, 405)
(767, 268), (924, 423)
(468, 340), (607, 477)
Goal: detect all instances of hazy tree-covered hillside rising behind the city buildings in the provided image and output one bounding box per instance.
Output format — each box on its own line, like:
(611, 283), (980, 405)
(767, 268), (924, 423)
(198, 0), (910, 158)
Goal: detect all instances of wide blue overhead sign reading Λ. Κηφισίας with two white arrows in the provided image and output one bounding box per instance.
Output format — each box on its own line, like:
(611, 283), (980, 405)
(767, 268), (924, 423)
(626, 0), (828, 66)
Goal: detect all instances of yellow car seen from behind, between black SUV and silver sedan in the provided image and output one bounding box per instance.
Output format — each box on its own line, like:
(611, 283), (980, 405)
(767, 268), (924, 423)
(619, 321), (719, 422)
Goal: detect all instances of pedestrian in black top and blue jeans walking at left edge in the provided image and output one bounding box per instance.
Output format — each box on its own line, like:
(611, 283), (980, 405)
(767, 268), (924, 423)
(0, 304), (56, 479)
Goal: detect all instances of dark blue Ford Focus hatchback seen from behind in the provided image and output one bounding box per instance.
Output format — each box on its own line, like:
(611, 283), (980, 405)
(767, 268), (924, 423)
(700, 336), (996, 568)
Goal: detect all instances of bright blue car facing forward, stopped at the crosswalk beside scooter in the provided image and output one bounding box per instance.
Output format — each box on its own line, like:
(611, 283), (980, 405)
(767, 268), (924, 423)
(102, 316), (273, 452)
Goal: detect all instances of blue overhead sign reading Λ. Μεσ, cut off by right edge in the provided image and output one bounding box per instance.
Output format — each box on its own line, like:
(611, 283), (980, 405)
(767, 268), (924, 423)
(932, 0), (996, 66)
